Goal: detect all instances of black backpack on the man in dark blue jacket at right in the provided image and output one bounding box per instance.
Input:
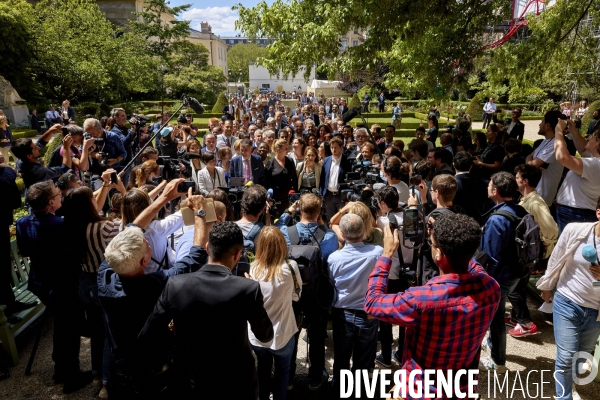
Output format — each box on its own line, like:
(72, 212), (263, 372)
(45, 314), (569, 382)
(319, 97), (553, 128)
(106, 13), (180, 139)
(492, 210), (543, 279)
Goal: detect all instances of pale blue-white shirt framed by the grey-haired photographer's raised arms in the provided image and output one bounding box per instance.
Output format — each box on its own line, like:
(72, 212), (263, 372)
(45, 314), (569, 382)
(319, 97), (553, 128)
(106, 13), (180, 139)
(144, 211), (183, 274)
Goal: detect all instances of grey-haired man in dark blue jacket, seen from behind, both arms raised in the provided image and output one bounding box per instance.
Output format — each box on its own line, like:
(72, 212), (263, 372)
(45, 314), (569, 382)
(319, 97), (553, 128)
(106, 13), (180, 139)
(98, 185), (213, 399)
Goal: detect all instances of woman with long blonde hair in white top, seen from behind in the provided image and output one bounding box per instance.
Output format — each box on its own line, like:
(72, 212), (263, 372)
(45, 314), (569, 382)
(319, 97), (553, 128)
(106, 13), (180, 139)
(248, 226), (302, 400)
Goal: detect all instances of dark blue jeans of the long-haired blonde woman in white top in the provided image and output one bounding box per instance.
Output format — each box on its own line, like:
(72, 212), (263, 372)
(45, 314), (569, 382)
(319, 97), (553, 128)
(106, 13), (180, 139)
(252, 336), (296, 400)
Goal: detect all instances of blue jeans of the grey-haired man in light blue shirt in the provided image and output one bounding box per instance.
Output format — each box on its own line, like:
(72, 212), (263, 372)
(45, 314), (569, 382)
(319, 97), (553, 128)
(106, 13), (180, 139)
(332, 308), (379, 382)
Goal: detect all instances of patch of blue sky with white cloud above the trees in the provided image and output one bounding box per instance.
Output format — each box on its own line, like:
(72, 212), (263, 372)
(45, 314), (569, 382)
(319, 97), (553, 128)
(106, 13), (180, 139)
(167, 0), (272, 36)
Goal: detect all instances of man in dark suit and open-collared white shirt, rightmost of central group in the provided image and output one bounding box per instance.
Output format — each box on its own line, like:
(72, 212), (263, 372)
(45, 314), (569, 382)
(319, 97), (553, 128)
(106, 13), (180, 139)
(319, 137), (352, 219)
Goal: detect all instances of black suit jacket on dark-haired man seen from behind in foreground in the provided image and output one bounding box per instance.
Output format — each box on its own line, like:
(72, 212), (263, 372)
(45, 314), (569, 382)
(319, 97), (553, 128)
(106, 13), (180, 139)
(139, 264), (273, 400)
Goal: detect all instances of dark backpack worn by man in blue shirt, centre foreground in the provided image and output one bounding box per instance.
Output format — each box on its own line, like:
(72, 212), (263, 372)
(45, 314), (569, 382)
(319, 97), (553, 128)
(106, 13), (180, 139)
(288, 225), (334, 309)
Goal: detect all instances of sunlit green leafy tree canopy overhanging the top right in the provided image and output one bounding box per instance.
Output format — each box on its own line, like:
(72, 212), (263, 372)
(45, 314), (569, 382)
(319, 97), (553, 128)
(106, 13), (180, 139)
(234, 0), (600, 98)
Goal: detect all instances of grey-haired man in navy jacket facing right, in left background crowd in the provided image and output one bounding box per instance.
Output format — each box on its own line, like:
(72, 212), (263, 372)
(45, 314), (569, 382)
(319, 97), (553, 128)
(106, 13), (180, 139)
(83, 118), (127, 189)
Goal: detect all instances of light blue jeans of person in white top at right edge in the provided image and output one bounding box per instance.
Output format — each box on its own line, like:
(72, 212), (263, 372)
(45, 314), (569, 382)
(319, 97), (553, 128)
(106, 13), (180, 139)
(553, 292), (600, 400)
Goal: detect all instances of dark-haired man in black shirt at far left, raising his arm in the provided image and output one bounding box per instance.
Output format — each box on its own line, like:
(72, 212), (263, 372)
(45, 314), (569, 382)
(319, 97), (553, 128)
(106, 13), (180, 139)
(11, 124), (73, 188)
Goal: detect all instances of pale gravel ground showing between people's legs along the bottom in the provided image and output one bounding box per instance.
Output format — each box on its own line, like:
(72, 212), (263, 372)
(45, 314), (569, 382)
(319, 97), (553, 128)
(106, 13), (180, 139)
(0, 299), (600, 400)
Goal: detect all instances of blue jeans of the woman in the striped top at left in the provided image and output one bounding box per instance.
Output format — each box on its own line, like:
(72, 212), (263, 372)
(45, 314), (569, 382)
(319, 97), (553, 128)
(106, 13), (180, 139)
(79, 272), (110, 385)
